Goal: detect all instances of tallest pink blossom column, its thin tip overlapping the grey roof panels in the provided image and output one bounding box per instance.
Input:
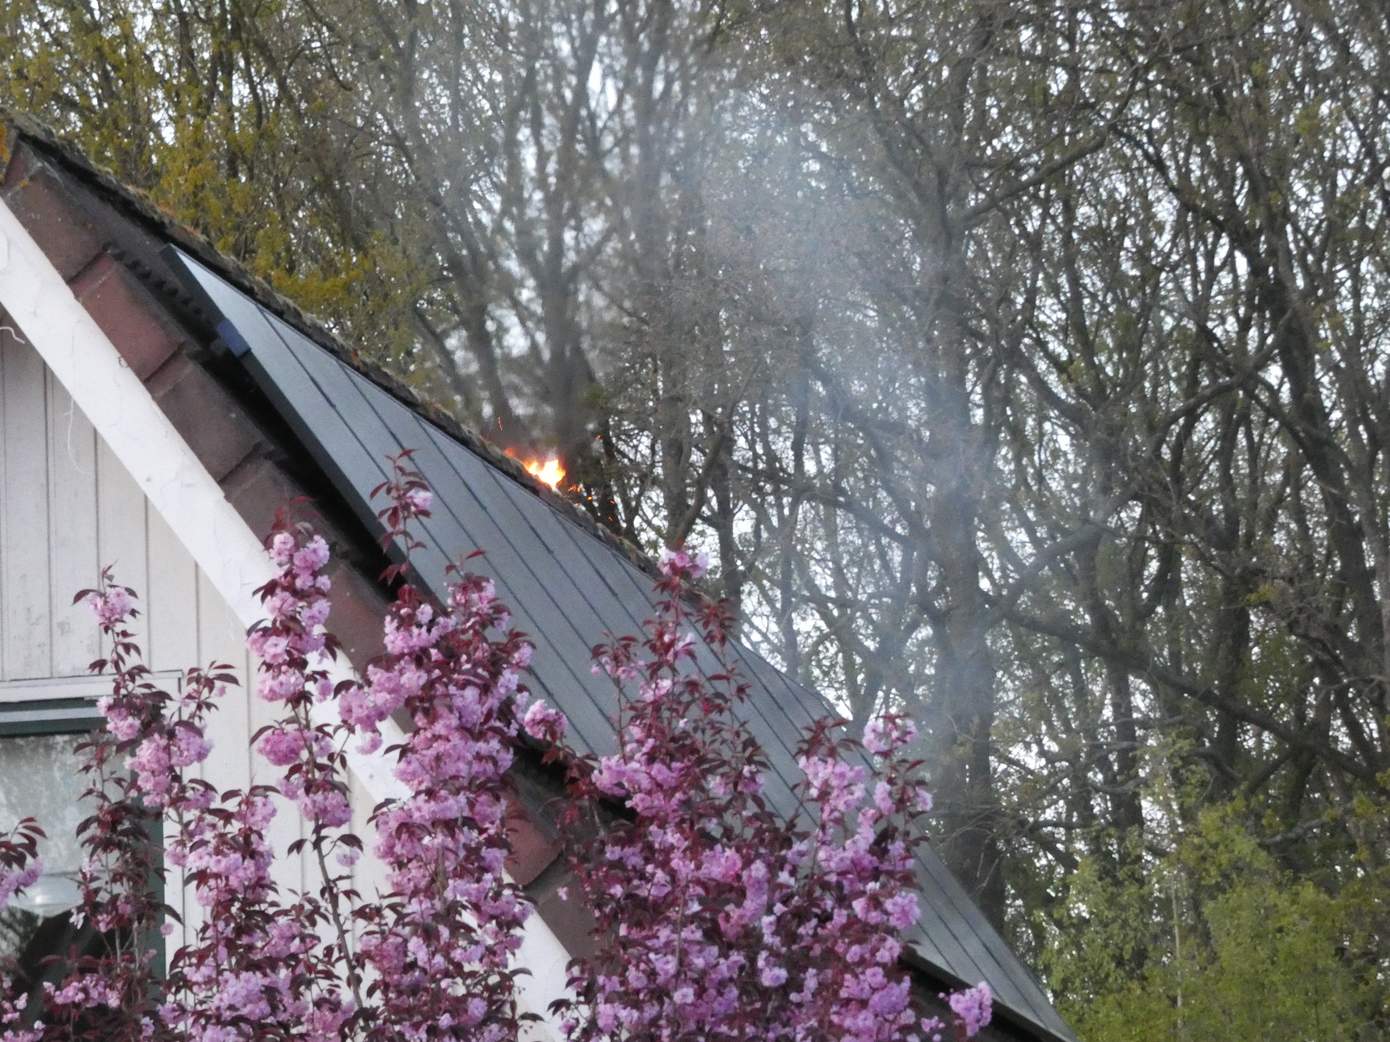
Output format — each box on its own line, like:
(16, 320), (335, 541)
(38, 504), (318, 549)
(339, 461), (531, 1042)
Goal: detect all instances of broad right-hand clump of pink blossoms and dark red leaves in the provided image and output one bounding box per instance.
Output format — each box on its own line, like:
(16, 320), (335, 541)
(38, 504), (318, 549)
(525, 550), (988, 1042)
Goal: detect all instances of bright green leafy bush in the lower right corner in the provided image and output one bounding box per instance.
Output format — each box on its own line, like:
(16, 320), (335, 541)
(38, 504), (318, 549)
(1047, 804), (1390, 1042)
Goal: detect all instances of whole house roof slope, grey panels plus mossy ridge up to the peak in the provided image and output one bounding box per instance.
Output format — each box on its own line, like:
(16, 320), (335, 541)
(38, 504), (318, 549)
(0, 113), (1074, 1042)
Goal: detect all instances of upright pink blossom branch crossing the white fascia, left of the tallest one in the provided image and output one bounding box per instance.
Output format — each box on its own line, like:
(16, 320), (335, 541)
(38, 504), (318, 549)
(160, 520), (366, 1042)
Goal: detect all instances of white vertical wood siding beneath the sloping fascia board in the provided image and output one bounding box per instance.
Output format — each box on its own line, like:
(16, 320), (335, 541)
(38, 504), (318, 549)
(0, 338), (379, 923)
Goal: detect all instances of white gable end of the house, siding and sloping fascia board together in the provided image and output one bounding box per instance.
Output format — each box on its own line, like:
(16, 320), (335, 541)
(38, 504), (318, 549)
(0, 201), (569, 1039)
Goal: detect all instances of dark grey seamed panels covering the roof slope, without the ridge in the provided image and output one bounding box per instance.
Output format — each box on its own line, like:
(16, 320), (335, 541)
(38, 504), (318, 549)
(167, 246), (1074, 1042)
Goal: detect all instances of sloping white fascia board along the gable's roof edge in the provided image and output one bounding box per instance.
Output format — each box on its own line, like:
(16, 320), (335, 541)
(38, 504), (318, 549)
(0, 200), (569, 1028)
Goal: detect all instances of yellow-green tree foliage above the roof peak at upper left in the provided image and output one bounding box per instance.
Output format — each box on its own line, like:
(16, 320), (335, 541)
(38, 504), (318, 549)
(0, 0), (421, 368)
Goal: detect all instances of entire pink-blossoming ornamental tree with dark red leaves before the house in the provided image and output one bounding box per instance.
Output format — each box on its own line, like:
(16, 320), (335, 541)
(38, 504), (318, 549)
(0, 453), (990, 1042)
